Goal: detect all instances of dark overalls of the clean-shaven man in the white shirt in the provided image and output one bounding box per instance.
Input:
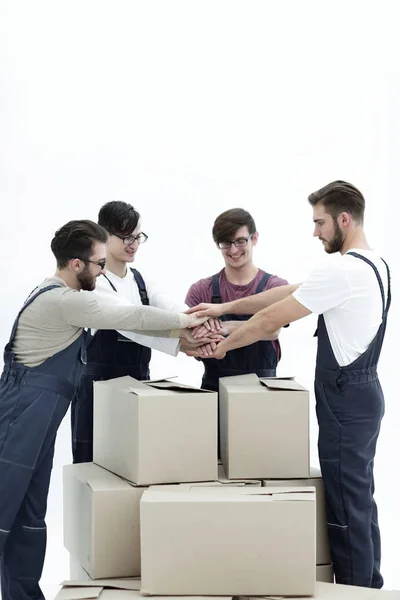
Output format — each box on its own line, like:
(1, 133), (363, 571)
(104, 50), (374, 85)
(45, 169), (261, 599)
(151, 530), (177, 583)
(71, 269), (151, 463)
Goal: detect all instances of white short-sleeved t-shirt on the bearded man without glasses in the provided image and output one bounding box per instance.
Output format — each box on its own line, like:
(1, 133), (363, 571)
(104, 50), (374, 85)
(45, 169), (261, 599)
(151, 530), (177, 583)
(293, 249), (388, 367)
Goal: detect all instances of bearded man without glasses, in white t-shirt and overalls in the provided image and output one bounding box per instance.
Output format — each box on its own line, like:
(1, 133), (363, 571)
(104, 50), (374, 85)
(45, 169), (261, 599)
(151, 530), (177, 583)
(191, 181), (390, 588)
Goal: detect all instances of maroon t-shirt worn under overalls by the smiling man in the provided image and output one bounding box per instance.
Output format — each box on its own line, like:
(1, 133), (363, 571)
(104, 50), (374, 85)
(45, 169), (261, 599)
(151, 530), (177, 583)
(185, 269), (288, 360)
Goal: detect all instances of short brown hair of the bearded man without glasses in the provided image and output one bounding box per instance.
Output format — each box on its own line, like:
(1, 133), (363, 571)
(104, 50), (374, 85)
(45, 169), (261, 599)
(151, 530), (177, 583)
(308, 180), (365, 223)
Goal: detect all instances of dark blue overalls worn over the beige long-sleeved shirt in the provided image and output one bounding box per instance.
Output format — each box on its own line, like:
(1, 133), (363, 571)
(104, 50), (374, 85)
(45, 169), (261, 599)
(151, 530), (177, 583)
(0, 285), (86, 600)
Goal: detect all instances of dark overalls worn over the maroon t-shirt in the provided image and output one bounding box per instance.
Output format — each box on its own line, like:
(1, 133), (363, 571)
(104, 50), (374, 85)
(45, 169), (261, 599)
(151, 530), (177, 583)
(201, 273), (278, 391)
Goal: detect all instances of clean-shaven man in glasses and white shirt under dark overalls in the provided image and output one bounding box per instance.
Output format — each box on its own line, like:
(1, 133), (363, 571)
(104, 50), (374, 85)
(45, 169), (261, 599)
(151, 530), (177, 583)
(71, 201), (222, 463)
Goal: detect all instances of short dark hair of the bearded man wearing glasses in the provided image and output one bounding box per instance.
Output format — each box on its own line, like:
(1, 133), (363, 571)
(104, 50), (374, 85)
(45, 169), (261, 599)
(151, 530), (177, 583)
(51, 220), (108, 269)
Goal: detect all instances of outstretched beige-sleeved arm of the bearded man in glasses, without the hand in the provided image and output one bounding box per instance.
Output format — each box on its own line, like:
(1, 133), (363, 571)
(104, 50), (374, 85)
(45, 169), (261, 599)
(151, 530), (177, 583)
(63, 293), (187, 337)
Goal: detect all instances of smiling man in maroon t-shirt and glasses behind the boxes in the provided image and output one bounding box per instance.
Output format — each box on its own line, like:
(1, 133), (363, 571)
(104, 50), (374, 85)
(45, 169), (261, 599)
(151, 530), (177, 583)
(186, 208), (288, 391)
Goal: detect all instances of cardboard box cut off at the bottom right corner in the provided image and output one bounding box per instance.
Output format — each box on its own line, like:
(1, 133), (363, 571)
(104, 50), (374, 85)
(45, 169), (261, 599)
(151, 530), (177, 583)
(254, 582), (400, 600)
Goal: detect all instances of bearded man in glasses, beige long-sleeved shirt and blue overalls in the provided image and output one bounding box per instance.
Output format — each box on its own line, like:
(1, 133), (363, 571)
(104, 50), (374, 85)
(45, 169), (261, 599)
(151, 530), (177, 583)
(0, 221), (205, 600)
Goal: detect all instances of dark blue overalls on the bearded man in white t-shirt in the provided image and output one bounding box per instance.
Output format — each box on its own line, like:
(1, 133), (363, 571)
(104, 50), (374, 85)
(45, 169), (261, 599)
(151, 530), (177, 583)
(315, 252), (391, 588)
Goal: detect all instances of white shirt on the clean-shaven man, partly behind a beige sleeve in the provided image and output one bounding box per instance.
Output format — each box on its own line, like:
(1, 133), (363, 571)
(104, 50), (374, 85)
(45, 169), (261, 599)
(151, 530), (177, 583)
(89, 268), (188, 356)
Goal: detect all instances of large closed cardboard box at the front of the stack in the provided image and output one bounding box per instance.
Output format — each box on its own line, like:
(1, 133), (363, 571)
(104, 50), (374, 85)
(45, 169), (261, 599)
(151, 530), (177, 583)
(140, 486), (316, 596)
